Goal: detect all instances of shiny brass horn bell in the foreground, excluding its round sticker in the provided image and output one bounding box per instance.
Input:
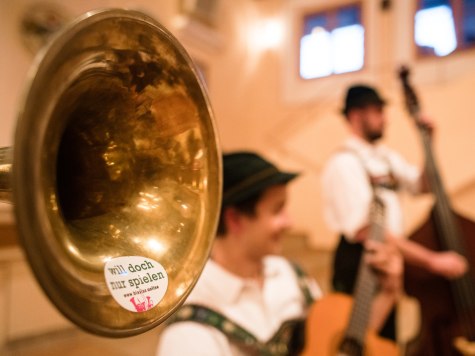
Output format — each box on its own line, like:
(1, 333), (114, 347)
(0, 9), (222, 337)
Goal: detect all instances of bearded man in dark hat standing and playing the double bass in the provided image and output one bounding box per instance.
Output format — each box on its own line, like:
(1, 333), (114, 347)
(322, 84), (466, 339)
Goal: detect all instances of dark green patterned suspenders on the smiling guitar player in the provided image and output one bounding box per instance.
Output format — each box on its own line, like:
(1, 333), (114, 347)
(169, 263), (314, 356)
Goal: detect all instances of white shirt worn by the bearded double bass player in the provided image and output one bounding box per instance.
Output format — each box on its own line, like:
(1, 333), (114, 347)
(322, 136), (421, 241)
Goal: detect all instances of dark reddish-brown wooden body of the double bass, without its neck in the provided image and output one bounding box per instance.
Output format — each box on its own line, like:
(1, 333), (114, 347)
(404, 213), (475, 356)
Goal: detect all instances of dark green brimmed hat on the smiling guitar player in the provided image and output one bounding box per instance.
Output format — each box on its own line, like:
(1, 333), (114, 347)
(223, 151), (298, 206)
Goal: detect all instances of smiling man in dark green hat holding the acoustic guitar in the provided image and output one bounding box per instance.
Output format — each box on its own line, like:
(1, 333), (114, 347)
(157, 152), (402, 356)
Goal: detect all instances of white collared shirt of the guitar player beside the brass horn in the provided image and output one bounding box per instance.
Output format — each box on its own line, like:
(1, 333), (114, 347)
(157, 256), (321, 356)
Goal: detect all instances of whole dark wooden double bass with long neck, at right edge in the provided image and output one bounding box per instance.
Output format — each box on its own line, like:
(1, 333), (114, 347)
(399, 67), (475, 356)
